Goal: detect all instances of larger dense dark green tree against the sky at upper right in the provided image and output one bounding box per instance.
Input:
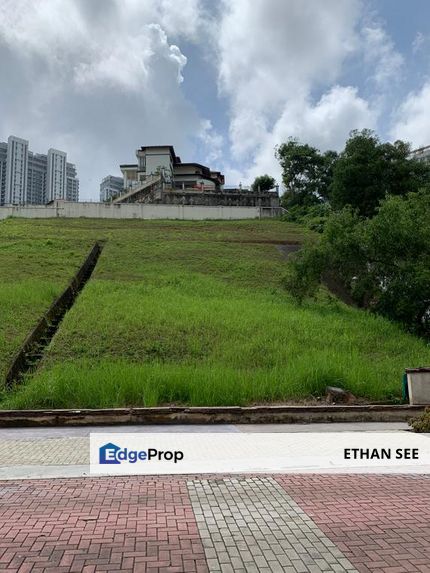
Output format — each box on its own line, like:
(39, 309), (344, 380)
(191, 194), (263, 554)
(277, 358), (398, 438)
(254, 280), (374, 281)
(329, 129), (430, 217)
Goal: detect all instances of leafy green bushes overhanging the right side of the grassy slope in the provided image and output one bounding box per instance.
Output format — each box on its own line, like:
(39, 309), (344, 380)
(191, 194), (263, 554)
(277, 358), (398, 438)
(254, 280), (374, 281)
(284, 190), (430, 337)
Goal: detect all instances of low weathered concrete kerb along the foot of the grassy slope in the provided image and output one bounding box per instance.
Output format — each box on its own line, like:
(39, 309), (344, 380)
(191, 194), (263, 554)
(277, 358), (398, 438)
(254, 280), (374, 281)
(0, 405), (425, 427)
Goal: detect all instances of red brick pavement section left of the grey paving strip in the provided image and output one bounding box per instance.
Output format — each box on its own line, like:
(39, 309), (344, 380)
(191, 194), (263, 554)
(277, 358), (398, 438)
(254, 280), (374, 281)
(0, 477), (207, 573)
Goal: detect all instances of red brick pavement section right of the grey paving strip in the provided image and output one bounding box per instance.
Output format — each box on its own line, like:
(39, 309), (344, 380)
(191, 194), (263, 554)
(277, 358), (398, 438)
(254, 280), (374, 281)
(276, 475), (430, 573)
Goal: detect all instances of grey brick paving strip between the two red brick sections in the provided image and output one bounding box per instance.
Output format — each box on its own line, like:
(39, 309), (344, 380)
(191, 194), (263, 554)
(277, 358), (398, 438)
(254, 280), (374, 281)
(187, 477), (357, 573)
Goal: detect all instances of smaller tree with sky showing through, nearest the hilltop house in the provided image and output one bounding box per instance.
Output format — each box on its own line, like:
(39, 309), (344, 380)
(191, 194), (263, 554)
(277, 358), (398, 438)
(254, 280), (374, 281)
(276, 138), (337, 208)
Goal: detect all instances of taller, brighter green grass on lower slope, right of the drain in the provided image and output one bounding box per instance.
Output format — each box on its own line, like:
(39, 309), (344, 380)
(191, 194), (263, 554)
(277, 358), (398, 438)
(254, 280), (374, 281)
(3, 277), (427, 408)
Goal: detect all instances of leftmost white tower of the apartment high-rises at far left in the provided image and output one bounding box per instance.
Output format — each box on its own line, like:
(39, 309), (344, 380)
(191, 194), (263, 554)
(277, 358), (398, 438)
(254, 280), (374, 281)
(5, 135), (28, 205)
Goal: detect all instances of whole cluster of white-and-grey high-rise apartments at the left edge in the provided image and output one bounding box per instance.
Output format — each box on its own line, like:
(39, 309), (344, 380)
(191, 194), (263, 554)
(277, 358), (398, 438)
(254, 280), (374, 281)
(0, 136), (79, 205)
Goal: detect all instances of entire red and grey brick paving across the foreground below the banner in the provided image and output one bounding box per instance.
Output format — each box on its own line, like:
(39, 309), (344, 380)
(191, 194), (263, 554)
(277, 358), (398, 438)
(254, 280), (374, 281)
(0, 474), (430, 573)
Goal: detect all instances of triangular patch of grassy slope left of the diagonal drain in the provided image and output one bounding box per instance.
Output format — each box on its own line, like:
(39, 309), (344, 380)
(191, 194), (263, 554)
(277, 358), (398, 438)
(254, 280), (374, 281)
(0, 219), (90, 381)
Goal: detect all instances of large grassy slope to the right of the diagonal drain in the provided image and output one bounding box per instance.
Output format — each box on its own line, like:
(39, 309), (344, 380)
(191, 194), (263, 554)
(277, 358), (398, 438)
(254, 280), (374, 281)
(3, 214), (429, 408)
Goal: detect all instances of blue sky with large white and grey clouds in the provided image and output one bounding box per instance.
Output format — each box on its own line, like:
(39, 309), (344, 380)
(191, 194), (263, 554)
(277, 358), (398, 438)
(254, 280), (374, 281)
(0, 0), (430, 200)
